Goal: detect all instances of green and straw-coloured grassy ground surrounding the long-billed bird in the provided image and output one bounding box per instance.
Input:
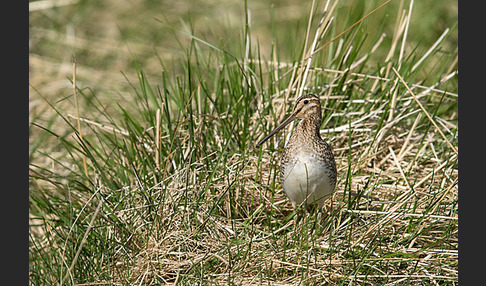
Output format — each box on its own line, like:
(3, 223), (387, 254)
(29, 0), (458, 285)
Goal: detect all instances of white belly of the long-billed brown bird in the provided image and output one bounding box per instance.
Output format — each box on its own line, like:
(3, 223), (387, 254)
(282, 155), (333, 208)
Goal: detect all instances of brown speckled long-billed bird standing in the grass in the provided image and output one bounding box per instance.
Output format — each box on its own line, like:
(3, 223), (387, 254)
(256, 94), (337, 212)
